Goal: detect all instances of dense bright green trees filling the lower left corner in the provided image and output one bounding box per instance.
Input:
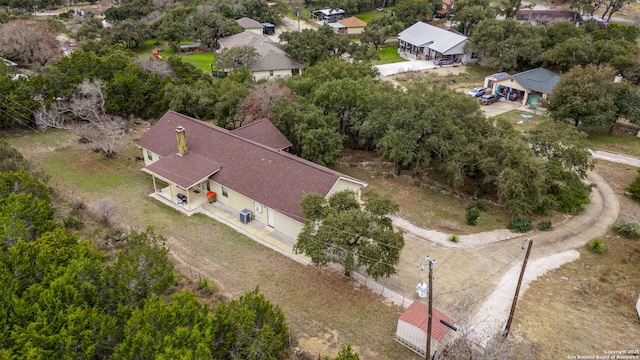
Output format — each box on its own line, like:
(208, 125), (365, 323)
(0, 146), (289, 359)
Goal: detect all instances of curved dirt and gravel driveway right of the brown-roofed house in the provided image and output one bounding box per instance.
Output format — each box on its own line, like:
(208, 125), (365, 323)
(380, 172), (620, 343)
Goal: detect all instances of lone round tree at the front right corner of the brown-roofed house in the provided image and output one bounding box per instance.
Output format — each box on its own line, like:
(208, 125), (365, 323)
(294, 190), (404, 279)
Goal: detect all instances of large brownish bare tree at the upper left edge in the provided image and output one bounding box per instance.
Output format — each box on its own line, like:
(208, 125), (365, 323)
(0, 20), (62, 66)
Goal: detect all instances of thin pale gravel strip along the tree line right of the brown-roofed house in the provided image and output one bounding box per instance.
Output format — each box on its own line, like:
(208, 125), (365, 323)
(391, 216), (524, 248)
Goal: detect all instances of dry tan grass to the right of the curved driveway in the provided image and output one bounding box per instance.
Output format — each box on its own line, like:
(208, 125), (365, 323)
(513, 162), (640, 359)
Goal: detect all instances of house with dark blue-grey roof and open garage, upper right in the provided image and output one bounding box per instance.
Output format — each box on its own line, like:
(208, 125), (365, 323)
(485, 68), (560, 105)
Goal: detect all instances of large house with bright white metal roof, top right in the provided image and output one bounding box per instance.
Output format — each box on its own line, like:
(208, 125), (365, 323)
(398, 21), (478, 64)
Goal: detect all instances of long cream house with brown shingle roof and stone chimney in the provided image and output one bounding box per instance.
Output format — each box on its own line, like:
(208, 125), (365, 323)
(138, 111), (367, 238)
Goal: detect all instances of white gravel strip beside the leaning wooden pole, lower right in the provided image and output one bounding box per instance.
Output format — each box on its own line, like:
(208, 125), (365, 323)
(468, 250), (580, 346)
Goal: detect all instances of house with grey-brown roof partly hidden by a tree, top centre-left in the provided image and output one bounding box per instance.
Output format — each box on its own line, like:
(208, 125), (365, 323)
(218, 31), (303, 80)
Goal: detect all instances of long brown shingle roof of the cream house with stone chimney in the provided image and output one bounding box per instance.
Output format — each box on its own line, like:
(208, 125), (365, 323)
(138, 111), (366, 222)
